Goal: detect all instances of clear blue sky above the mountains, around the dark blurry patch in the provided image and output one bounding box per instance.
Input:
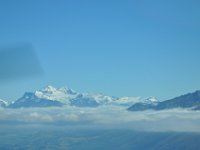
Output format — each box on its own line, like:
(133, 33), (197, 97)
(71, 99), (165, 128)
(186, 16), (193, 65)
(0, 0), (200, 100)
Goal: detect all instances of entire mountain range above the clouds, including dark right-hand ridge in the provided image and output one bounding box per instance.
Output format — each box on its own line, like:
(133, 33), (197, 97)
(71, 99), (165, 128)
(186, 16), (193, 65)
(0, 86), (200, 111)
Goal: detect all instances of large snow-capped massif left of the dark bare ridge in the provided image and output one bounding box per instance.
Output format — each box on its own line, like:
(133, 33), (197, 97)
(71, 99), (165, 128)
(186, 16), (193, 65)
(9, 86), (141, 108)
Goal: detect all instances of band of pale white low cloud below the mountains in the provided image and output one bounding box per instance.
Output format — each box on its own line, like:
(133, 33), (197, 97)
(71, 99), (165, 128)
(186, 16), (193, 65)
(0, 107), (200, 132)
